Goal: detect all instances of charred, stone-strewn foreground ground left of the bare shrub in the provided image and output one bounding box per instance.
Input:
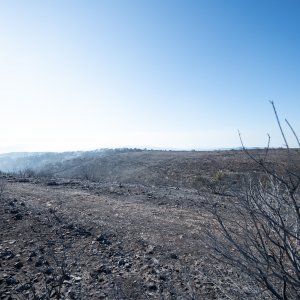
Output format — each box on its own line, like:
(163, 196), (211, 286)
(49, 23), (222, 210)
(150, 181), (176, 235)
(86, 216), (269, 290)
(0, 152), (294, 299)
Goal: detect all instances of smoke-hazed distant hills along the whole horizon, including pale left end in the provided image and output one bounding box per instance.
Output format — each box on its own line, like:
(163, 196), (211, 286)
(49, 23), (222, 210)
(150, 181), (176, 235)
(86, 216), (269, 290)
(0, 148), (300, 189)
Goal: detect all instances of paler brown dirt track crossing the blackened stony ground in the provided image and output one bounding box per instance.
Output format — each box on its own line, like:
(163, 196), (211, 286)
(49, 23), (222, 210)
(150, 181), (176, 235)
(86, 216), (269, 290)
(7, 183), (207, 255)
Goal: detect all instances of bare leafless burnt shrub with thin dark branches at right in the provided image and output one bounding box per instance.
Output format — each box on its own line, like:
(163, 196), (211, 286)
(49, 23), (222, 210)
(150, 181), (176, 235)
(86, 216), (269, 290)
(207, 102), (300, 300)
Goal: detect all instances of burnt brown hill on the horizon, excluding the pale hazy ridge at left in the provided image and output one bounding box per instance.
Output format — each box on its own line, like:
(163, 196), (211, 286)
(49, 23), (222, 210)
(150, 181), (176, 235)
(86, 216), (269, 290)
(37, 149), (300, 188)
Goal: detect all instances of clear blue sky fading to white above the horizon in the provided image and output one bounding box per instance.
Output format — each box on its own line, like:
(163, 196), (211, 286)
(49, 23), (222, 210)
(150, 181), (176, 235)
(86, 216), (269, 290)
(0, 0), (300, 152)
